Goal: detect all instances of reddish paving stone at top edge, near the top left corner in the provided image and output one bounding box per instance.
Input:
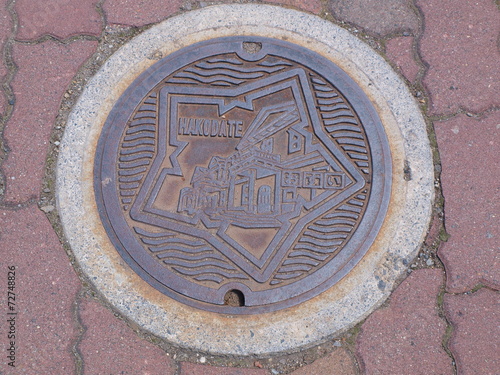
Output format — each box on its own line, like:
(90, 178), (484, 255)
(15, 0), (102, 40)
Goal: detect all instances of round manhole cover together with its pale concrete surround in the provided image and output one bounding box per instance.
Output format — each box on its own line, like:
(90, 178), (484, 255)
(57, 4), (434, 355)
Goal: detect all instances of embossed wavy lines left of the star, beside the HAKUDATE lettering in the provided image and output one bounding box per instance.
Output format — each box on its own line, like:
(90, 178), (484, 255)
(118, 94), (157, 210)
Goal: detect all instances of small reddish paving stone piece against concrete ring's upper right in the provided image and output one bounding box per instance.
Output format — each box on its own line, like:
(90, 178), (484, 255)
(386, 37), (419, 82)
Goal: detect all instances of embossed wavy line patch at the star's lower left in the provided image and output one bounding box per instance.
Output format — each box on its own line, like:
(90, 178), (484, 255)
(134, 227), (248, 284)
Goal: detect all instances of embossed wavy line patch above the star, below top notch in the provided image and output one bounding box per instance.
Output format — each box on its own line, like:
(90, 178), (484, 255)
(167, 57), (291, 87)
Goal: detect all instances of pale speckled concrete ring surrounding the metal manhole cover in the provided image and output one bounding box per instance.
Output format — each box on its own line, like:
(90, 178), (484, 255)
(56, 4), (434, 355)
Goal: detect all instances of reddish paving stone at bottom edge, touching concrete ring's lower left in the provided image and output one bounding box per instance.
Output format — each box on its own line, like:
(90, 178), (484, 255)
(78, 298), (175, 375)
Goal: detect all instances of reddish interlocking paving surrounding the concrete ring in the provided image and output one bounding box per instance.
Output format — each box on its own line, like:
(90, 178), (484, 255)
(0, 0), (500, 375)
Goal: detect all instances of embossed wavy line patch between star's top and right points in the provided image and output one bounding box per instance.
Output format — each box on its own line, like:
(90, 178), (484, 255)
(311, 77), (370, 175)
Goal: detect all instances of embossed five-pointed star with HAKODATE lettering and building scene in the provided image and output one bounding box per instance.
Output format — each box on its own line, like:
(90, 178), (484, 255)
(131, 68), (365, 282)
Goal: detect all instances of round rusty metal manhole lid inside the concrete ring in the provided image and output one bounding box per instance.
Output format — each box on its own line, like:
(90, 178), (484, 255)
(94, 37), (391, 314)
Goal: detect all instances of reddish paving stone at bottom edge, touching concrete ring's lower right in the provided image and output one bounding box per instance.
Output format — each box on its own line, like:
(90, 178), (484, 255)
(357, 269), (453, 375)
